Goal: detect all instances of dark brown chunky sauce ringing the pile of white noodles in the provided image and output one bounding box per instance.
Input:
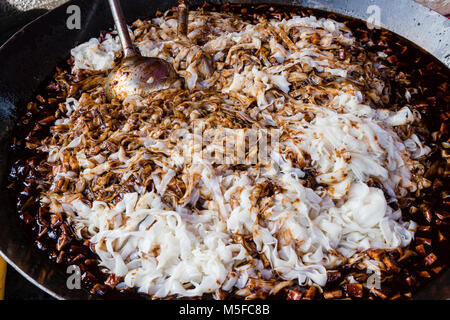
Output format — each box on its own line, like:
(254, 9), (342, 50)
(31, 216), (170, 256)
(5, 1), (450, 299)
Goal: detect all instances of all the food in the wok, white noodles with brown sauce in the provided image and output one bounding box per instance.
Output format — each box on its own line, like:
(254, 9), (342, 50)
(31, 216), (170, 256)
(6, 3), (450, 299)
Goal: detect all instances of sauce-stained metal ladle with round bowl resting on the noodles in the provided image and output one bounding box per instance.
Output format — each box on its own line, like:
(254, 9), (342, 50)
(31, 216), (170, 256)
(105, 0), (183, 100)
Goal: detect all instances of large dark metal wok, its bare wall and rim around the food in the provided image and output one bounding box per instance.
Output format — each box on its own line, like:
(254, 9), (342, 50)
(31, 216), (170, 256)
(0, 0), (450, 299)
